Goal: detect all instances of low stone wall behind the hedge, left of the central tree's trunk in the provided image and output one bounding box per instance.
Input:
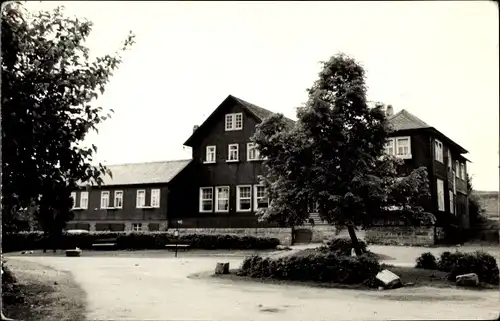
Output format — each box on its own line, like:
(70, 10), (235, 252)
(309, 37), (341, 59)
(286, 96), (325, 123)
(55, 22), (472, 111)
(169, 227), (292, 245)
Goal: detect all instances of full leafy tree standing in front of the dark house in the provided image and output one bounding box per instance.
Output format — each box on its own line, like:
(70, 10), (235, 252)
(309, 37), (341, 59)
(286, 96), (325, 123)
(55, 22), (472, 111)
(253, 54), (435, 255)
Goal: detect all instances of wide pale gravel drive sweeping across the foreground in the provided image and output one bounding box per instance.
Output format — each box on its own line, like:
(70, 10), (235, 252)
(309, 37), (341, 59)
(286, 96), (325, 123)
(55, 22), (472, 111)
(5, 254), (500, 321)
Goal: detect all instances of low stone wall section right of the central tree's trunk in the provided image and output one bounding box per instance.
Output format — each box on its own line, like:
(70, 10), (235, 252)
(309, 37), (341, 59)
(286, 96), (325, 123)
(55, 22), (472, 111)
(365, 226), (435, 245)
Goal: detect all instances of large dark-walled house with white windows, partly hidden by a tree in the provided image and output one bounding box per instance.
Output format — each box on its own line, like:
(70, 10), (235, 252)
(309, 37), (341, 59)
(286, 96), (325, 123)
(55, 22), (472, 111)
(67, 95), (468, 231)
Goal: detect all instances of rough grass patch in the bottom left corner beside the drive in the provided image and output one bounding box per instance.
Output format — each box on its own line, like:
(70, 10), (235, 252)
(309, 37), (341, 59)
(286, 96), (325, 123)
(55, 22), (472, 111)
(3, 258), (86, 321)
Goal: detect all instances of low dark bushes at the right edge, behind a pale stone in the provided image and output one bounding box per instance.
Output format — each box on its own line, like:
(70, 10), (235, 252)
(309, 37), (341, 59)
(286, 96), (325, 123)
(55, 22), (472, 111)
(416, 251), (499, 284)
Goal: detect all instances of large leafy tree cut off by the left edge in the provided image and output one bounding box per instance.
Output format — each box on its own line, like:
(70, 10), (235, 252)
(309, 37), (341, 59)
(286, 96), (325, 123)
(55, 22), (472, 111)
(1, 2), (133, 233)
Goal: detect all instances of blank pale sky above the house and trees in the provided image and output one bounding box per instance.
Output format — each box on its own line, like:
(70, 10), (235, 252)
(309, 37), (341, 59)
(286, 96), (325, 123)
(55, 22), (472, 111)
(28, 1), (499, 190)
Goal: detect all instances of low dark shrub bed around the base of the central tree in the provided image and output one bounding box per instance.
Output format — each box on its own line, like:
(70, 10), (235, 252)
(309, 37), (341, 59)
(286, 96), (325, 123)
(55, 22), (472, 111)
(238, 252), (380, 284)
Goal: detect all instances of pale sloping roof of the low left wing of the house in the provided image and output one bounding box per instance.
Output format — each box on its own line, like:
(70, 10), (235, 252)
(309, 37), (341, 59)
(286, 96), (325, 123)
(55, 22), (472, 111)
(81, 159), (191, 185)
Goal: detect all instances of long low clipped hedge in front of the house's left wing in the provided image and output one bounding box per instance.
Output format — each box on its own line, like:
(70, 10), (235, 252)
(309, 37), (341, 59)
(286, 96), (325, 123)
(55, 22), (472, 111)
(2, 232), (280, 252)
